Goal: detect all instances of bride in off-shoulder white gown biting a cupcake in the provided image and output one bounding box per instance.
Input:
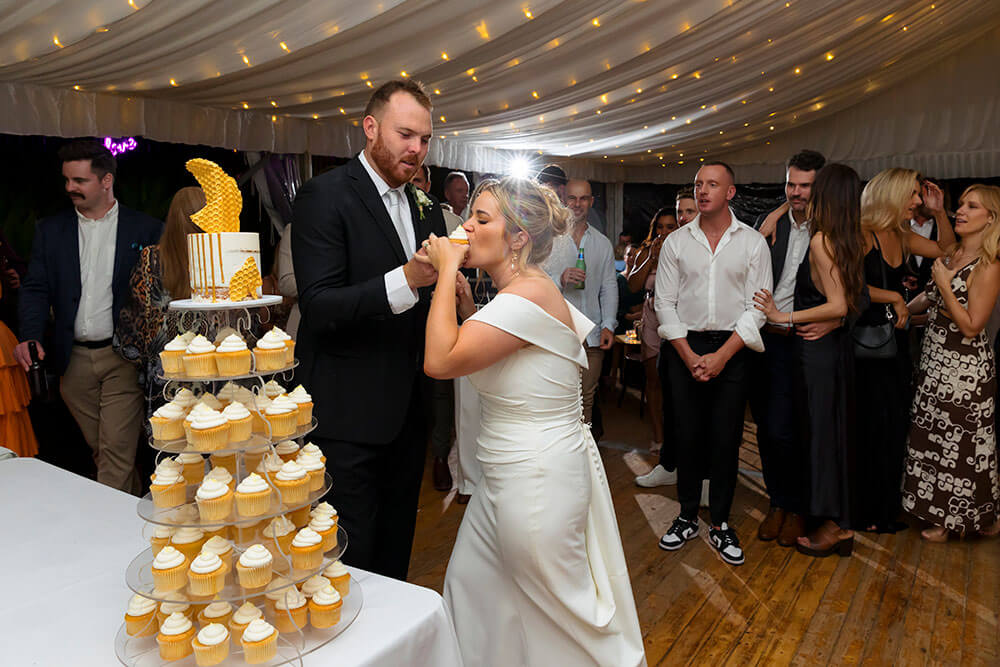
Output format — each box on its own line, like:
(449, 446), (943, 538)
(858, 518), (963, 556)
(421, 179), (646, 667)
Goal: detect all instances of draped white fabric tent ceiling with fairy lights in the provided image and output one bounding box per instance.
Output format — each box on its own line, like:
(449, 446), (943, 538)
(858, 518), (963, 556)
(0, 0), (1000, 182)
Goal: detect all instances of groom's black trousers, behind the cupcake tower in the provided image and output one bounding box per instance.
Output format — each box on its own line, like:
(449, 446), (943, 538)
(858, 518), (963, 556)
(307, 379), (427, 581)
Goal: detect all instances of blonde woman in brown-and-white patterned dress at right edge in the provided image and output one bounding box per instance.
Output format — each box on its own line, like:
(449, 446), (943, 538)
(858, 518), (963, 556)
(903, 185), (1000, 542)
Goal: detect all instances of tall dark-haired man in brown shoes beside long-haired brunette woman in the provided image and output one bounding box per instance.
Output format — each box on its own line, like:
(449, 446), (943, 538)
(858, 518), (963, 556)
(750, 150), (839, 547)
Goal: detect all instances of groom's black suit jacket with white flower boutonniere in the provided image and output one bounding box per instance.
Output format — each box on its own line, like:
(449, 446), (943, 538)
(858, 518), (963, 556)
(292, 157), (446, 445)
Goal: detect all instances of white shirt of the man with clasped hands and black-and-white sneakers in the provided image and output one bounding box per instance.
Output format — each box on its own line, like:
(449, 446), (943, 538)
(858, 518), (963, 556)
(654, 209), (772, 352)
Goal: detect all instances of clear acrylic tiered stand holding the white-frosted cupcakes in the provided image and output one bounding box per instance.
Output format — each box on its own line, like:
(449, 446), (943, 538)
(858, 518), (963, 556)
(115, 295), (364, 667)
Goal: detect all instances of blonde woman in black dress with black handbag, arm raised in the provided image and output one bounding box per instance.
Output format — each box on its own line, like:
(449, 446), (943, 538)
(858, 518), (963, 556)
(853, 168), (955, 532)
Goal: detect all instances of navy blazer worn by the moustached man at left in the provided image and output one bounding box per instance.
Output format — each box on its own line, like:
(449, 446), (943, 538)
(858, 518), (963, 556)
(18, 202), (163, 375)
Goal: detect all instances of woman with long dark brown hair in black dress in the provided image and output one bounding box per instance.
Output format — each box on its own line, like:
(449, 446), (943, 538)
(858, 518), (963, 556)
(754, 164), (864, 556)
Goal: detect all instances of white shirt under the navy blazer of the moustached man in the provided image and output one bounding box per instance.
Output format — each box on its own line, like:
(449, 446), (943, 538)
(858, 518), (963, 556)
(73, 201), (118, 341)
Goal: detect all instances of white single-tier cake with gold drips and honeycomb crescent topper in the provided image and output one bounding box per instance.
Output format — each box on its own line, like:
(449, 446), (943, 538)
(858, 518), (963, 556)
(185, 158), (262, 302)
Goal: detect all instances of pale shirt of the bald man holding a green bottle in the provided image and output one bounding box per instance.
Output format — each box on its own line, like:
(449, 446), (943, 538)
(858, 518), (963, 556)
(543, 225), (618, 347)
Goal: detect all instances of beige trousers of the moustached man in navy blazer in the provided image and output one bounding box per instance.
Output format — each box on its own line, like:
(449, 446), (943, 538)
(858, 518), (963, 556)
(59, 345), (144, 494)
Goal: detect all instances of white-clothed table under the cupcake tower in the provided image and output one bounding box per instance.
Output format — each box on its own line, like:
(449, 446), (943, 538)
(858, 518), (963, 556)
(0, 458), (462, 667)
